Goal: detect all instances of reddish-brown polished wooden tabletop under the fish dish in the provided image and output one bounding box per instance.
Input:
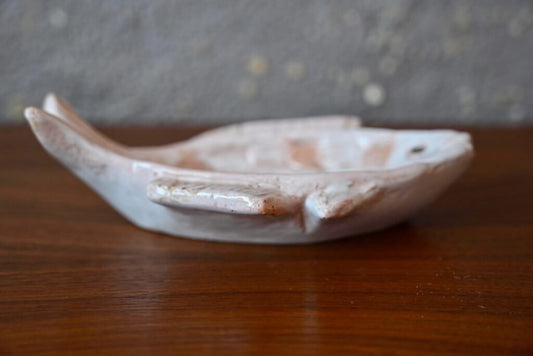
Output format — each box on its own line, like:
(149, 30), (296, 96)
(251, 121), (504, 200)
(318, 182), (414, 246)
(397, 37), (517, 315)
(0, 127), (533, 355)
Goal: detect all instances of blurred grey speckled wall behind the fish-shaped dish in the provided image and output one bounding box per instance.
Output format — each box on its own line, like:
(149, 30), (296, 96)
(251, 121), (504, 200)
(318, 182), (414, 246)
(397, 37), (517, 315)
(0, 0), (533, 125)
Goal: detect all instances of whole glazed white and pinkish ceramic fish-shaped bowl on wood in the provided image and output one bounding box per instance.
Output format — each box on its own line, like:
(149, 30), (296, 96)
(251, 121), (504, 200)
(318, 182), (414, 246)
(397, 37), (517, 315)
(25, 94), (473, 244)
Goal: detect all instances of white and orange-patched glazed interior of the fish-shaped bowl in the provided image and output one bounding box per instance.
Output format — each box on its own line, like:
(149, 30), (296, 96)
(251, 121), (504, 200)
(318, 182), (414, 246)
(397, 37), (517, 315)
(166, 128), (460, 173)
